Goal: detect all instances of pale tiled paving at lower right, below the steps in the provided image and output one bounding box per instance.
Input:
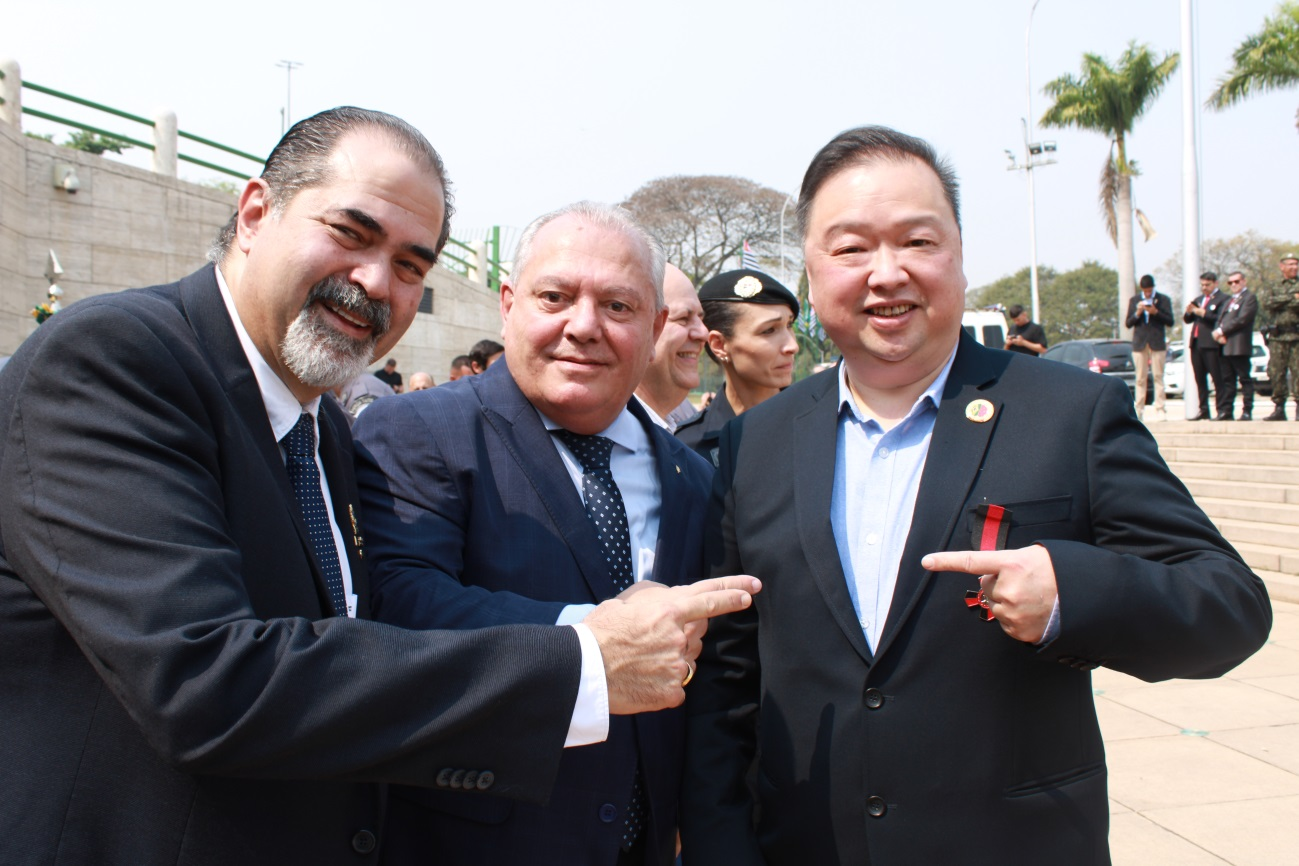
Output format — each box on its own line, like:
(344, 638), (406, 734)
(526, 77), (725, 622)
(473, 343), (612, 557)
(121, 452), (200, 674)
(1092, 601), (1299, 866)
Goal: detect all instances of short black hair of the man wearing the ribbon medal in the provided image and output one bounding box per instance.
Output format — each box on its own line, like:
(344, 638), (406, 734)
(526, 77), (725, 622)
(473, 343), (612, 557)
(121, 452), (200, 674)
(798, 126), (961, 235)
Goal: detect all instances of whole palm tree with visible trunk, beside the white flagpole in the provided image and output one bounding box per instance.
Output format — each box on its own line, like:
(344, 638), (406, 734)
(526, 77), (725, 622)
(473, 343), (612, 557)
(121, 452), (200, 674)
(1042, 42), (1178, 338)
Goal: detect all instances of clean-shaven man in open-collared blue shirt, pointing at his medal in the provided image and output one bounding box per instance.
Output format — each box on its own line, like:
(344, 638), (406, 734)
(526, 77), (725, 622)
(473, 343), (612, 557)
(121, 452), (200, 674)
(682, 127), (1272, 866)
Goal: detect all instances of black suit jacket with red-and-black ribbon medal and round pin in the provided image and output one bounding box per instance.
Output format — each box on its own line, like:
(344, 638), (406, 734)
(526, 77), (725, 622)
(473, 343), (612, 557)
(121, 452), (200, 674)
(682, 336), (1272, 866)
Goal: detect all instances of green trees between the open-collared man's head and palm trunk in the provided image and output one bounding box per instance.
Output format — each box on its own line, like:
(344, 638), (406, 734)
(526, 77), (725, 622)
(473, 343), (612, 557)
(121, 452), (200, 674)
(966, 261), (1118, 345)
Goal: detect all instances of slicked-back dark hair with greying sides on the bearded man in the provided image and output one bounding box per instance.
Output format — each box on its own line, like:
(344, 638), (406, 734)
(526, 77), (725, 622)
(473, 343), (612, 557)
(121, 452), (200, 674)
(208, 105), (456, 262)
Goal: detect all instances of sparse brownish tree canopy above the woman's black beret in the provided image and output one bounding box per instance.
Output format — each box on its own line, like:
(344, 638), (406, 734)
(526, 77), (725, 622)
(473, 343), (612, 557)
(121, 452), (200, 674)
(622, 175), (801, 286)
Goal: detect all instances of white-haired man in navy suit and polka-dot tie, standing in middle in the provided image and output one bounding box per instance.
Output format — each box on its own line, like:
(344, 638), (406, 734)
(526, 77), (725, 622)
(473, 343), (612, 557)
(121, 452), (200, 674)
(356, 203), (712, 866)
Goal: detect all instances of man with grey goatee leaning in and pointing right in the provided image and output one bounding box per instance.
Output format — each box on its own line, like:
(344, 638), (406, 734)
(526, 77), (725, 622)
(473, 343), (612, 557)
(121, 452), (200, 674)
(0, 108), (758, 866)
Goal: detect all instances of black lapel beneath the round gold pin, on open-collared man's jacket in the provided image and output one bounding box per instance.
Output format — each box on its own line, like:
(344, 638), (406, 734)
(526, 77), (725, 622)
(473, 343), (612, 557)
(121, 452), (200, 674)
(876, 334), (1009, 658)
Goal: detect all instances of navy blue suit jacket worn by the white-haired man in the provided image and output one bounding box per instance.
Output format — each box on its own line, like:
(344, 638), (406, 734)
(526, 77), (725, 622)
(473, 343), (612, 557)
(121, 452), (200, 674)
(355, 361), (712, 866)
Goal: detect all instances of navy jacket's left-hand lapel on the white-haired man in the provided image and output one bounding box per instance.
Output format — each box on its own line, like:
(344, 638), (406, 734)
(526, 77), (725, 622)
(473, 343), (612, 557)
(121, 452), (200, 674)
(469, 358), (617, 600)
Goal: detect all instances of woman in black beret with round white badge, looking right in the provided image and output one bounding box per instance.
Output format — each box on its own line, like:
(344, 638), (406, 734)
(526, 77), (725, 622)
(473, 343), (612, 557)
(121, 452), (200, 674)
(677, 269), (799, 466)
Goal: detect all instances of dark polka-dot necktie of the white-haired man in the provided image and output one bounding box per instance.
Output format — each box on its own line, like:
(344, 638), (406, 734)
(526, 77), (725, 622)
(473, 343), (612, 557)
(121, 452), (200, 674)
(552, 430), (646, 850)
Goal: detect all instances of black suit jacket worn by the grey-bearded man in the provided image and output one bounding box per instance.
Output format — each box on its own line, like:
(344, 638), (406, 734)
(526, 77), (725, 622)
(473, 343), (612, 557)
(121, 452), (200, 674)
(0, 267), (579, 866)
